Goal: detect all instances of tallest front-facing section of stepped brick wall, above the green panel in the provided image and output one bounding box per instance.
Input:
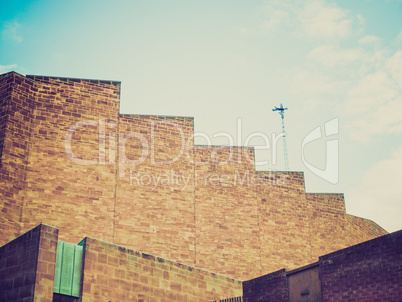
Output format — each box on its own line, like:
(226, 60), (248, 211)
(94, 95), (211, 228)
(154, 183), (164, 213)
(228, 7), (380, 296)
(22, 76), (120, 242)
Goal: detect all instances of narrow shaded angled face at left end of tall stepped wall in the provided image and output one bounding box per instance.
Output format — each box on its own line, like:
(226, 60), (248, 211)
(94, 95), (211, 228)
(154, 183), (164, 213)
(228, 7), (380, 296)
(0, 72), (35, 245)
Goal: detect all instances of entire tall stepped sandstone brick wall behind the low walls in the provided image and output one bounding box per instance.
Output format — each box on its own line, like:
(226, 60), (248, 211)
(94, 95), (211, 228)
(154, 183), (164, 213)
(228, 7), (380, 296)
(0, 72), (386, 280)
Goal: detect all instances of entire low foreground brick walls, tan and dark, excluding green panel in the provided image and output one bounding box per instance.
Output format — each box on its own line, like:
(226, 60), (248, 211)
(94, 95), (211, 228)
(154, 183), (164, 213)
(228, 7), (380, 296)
(0, 224), (402, 302)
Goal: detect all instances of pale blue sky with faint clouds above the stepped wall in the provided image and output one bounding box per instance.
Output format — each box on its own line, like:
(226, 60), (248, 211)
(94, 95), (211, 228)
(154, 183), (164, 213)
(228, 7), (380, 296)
(0, 0), (402, 231)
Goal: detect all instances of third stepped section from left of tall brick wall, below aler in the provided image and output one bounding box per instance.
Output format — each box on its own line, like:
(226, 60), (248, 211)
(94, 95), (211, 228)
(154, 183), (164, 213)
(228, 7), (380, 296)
(194, 147), (261, 279)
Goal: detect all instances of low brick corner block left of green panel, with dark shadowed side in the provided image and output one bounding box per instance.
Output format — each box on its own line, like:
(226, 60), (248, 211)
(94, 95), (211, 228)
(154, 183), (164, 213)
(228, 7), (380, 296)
(0, 224), (58, 302)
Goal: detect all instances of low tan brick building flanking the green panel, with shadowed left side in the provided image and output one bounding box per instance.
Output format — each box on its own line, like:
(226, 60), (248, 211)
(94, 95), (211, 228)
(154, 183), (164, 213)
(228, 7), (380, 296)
(0, 224), (243, 302)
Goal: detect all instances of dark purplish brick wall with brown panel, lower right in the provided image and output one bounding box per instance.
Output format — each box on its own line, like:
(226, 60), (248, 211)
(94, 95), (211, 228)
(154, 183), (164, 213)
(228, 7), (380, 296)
(243, 231), (402, 302)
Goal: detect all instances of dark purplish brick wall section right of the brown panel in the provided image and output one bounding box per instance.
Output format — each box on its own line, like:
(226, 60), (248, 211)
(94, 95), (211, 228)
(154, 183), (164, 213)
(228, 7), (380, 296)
(320, 230), (402, 302)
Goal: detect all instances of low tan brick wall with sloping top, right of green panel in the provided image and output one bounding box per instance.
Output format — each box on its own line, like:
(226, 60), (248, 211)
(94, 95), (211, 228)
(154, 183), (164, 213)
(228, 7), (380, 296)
(82, 237), (242, 302)
